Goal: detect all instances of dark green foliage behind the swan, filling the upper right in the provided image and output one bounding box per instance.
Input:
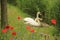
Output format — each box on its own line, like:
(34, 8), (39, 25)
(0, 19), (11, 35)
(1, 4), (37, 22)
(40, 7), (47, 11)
(8, 0), (60, 30)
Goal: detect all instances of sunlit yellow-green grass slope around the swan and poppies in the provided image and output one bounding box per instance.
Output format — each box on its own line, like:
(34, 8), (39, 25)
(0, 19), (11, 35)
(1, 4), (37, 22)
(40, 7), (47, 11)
(1, 4), (59, 40)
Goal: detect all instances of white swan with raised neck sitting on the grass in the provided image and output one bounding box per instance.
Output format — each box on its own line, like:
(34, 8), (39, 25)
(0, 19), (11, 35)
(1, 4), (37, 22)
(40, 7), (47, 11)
(24, 12), (41, 26)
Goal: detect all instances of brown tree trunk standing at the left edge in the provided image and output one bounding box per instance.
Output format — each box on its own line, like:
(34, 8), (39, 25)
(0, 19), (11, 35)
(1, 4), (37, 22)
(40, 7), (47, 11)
(1, 0), (7, 28)
